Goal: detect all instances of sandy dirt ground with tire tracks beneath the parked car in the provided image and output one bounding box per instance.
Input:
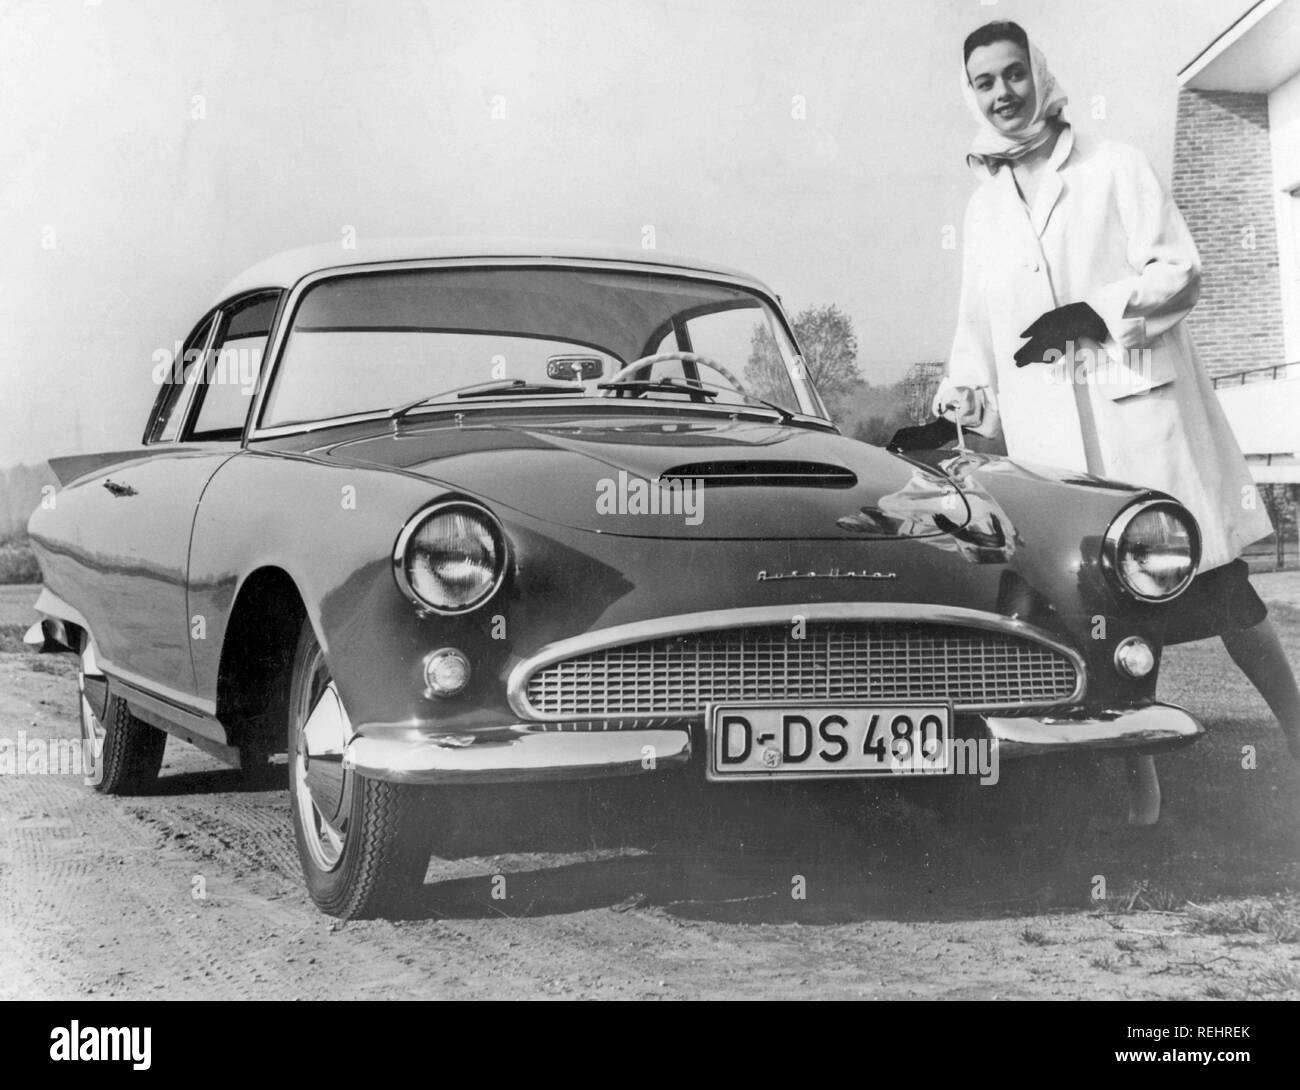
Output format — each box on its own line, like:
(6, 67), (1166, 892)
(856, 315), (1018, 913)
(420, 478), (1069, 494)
(0, 576), (1300, 999)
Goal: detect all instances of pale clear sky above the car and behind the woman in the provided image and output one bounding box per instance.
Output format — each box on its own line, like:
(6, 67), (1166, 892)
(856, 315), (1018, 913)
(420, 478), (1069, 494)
(0, 0), (1252, 467)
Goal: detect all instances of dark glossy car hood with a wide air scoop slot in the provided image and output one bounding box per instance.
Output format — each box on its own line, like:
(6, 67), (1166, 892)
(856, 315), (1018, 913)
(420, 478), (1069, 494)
(317, 418), (971, 540)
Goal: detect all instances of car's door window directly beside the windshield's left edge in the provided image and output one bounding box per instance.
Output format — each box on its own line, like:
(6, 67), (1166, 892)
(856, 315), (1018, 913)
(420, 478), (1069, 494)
(187, 291), (280, 442)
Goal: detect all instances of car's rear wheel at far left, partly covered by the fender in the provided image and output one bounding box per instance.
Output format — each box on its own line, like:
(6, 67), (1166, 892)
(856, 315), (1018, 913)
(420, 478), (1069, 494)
(77, 639), (166, 795)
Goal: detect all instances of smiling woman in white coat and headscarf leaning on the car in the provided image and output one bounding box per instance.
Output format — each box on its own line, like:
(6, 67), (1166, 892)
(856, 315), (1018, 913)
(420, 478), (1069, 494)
(935, 22), (1300, 758)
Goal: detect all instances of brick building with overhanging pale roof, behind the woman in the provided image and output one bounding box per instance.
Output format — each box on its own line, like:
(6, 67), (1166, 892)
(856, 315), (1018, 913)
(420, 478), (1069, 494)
(1174, 0), (1300, 484)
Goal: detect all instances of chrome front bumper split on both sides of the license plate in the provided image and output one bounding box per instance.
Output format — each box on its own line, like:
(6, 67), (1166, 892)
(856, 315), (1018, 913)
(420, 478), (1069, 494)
(343, 704), (1205, 783)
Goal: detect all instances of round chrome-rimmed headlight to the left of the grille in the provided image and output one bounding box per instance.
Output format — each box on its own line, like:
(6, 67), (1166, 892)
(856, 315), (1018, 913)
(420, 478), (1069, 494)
(393, 501), (506, 613)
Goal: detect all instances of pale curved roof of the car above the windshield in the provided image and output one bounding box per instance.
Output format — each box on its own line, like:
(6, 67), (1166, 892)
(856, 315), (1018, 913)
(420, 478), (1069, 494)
(215, 237), (770, 303)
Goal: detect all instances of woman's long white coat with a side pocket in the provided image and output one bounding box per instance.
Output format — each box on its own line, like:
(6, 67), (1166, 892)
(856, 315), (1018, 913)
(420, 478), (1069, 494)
(945, 127), (1273, 570)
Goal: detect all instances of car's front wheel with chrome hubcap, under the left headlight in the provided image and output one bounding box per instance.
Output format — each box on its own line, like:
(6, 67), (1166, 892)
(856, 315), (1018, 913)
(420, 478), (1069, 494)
(289, 622), (432, 920)
